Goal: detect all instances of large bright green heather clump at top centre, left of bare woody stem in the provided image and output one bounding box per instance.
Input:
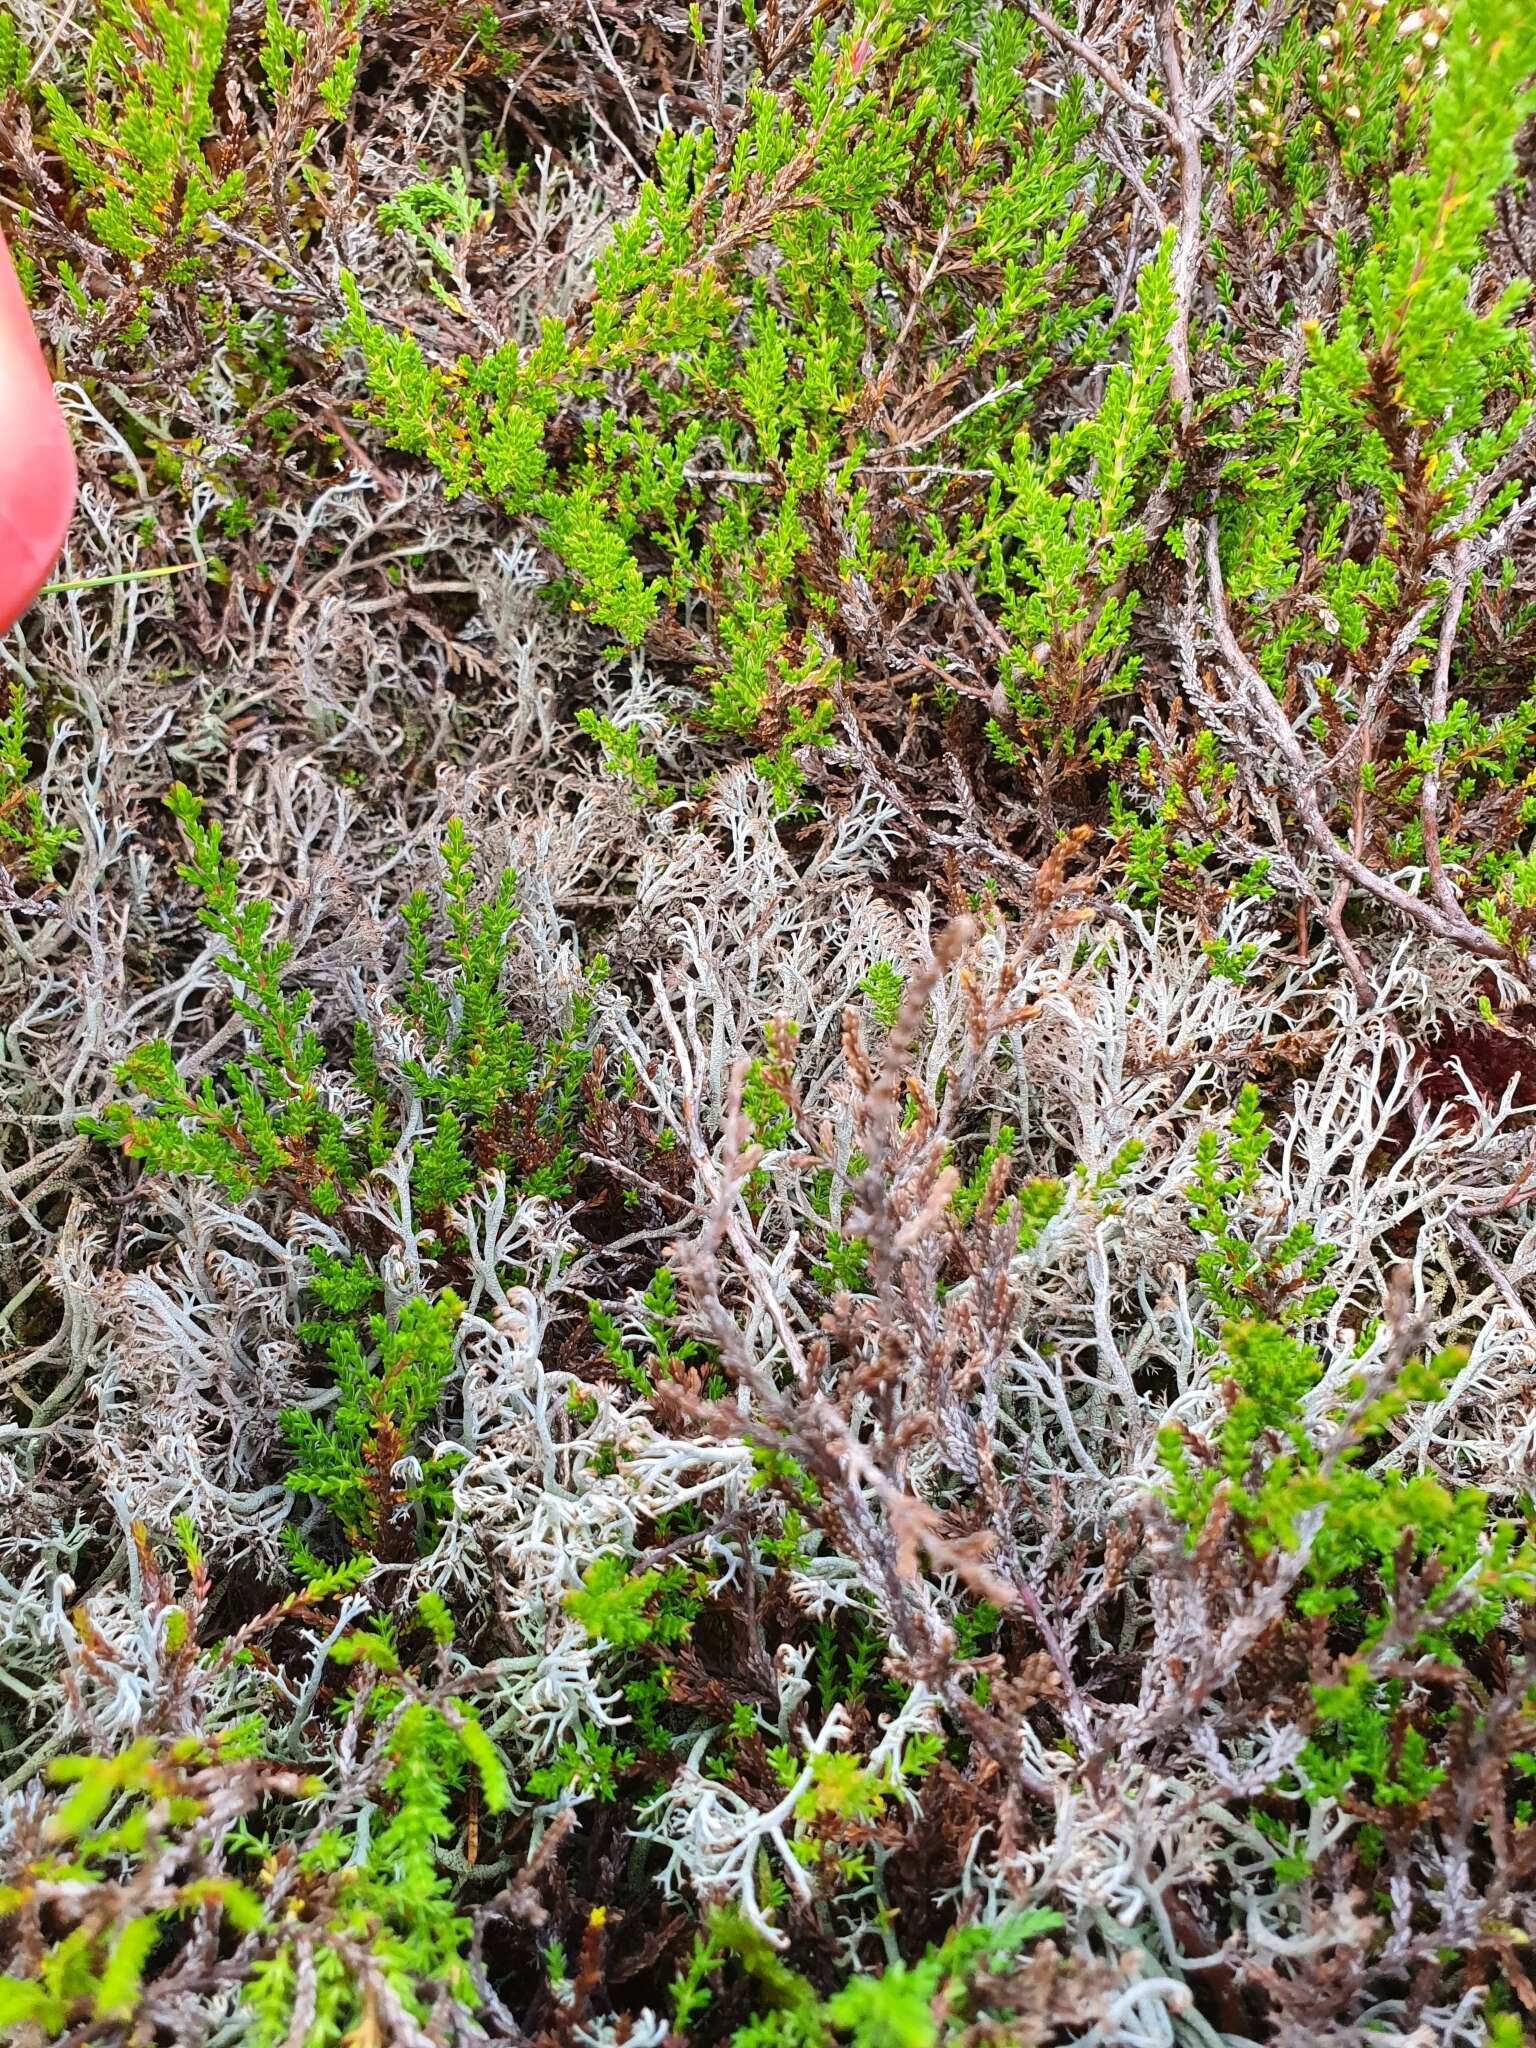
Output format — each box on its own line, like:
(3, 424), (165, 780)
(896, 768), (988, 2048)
(346, 0), (1146, 761)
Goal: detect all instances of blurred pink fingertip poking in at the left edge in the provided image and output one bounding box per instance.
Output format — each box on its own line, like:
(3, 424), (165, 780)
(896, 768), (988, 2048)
(0, 238), (74, 633)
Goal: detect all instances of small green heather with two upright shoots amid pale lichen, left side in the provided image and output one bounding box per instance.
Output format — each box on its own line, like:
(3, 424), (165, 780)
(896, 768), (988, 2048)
(88, 784), (590, 1223)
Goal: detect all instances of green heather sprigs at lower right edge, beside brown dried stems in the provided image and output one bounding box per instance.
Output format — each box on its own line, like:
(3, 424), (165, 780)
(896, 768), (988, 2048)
(1159, 1323), (1536, 1812)
